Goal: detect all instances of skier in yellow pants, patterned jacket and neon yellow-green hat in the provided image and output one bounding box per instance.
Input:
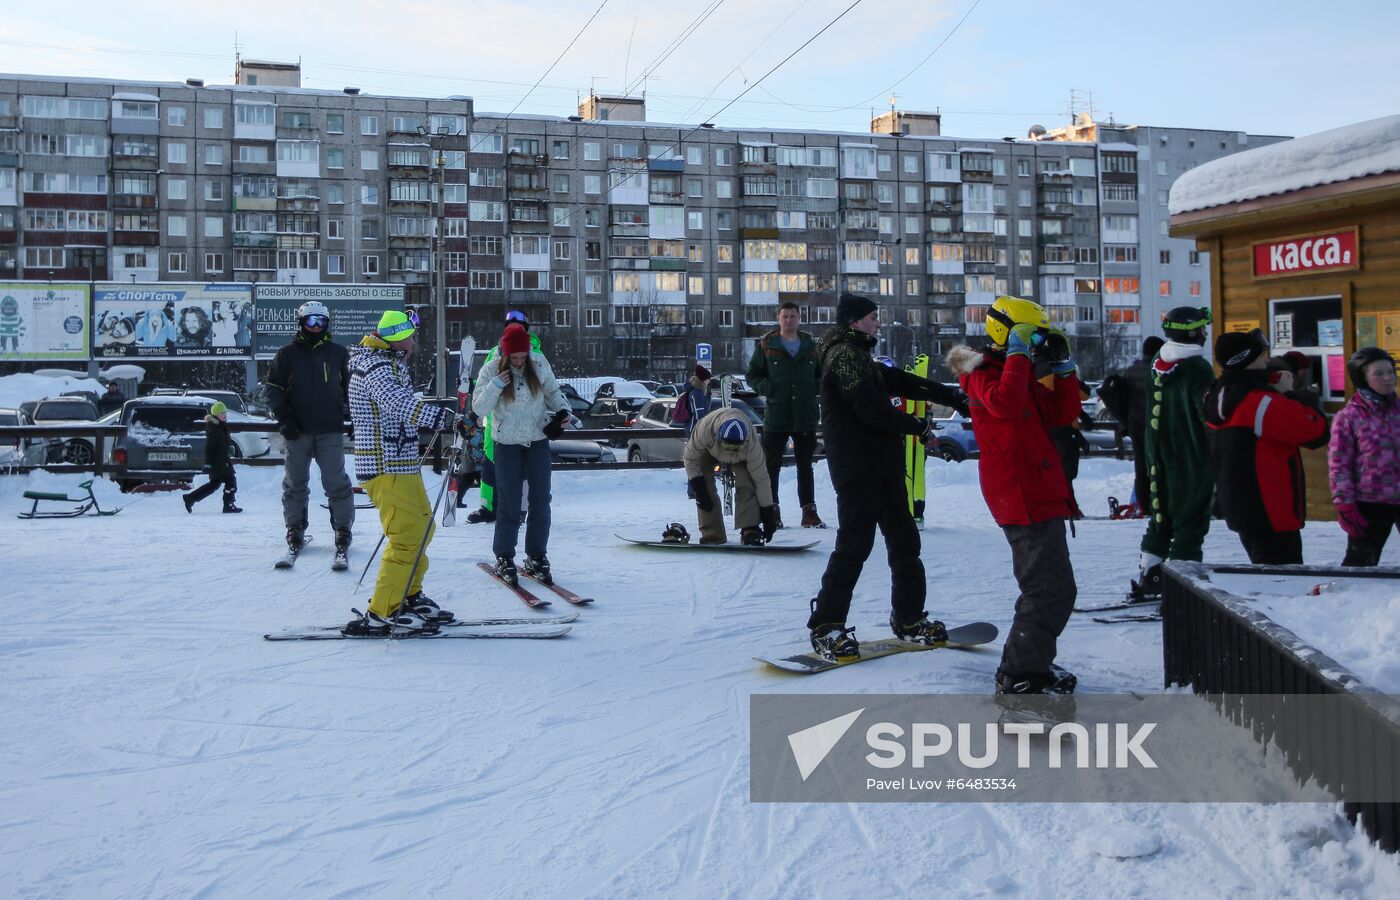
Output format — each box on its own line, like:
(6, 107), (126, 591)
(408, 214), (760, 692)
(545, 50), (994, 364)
(343, 309), (455, 637)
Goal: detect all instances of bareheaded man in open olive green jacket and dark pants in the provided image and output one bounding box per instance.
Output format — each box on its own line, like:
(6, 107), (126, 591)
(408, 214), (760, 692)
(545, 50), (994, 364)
(748, 301), (826, 528)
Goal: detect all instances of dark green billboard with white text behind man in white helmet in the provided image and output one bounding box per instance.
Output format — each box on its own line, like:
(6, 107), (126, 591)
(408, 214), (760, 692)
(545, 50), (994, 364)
(253, 284), (403, 360)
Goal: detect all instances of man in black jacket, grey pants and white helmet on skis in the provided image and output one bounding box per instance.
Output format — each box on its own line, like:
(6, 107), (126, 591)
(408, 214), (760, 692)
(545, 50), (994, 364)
(267, 300), (354, 553)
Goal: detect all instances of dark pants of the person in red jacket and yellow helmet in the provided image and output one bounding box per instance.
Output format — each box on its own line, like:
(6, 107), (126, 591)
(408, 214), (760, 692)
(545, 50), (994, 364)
(1001, 519), (1077, 676)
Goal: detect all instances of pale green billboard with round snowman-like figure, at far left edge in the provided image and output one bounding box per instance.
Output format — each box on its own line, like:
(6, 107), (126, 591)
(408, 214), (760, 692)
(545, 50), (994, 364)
(0, 281), (88, 363)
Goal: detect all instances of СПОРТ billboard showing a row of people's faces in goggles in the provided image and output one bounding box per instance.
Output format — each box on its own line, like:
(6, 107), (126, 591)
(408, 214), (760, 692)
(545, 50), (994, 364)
(92, 283), (253, 360)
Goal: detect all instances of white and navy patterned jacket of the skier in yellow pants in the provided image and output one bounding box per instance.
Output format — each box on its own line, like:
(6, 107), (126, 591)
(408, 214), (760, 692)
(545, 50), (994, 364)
(350, 335), (451, 481)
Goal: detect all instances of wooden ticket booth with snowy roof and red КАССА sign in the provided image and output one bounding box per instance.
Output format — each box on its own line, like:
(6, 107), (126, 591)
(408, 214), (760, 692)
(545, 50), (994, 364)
(1170, 116), (1400, 519)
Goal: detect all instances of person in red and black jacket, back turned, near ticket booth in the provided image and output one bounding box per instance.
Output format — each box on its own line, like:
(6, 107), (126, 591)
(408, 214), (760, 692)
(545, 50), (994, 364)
(1204, 329), (1327, 565)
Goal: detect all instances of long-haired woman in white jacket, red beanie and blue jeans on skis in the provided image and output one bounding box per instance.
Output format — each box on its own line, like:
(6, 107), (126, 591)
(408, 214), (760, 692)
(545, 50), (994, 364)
(472, 322), (568, 585)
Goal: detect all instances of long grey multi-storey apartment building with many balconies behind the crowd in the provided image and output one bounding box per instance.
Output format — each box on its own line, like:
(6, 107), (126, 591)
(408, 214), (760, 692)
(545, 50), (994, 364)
(0, 71), (1282, 377)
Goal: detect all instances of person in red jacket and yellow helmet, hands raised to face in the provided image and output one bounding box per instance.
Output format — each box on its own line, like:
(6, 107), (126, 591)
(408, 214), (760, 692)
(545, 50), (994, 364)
(948, 297), (1079, 694)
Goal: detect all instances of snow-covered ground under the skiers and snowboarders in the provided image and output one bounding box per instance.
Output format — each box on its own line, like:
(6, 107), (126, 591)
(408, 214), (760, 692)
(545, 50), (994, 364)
(0, 459), (1400, 897)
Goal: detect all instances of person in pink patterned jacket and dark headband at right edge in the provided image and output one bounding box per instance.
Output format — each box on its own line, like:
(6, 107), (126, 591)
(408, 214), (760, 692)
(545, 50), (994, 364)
(1327, 347), (1400, 565)
